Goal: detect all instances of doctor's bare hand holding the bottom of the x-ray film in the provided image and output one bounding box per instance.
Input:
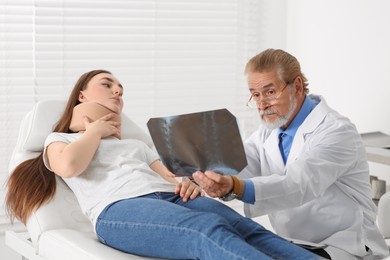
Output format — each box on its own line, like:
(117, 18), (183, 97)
(192, 171), (233, 198)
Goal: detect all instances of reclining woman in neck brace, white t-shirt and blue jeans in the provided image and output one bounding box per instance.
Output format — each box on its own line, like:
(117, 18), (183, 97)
(6, 70), (317, 260)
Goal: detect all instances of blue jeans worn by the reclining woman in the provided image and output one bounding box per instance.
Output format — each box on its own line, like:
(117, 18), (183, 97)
(96, 192), (318, 260)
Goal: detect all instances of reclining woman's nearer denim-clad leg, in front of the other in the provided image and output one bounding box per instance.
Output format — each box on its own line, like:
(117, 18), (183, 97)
(96, 197), (271, 260)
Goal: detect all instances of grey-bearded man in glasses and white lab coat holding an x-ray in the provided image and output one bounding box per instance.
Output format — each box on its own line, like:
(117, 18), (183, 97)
(193, 49), (388, 260)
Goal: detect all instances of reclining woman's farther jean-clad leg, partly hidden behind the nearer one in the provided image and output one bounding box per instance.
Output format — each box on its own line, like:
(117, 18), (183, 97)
(175, 194), (319, 259)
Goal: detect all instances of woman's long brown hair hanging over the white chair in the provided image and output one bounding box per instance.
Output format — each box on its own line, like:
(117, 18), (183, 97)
(5, 70), (111, 224)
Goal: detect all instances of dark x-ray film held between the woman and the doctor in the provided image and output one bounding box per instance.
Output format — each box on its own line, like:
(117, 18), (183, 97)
(147, 109), (247, 176)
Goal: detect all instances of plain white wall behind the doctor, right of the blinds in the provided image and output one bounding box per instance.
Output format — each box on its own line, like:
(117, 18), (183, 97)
(287, 0), (390, 134)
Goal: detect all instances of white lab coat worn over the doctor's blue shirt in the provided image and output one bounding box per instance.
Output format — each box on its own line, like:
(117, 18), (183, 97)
(240, 95), (388, 260)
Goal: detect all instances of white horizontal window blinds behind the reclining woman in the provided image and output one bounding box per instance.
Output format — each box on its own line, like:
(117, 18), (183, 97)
(0, 0), (261, 228)
